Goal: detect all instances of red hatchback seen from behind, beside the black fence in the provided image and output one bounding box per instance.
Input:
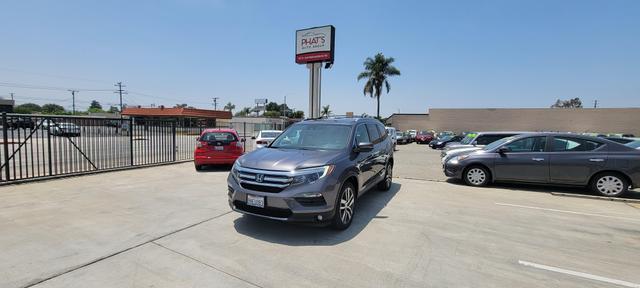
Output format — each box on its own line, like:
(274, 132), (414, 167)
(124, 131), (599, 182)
(193, 129), (244, 170)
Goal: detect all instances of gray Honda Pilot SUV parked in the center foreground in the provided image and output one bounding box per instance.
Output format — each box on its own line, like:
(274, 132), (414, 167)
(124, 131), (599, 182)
(227, 118), (393, 229)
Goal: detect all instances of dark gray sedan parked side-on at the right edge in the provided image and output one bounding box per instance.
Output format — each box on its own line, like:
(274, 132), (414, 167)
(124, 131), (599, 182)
(443, 133), (640, 196)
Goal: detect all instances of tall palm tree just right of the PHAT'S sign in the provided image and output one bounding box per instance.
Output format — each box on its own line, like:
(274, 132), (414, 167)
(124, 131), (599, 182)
(358, 53), (400, 118)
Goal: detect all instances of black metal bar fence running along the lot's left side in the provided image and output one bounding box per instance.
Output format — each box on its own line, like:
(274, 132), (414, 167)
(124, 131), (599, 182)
(0, 113), (284, 183)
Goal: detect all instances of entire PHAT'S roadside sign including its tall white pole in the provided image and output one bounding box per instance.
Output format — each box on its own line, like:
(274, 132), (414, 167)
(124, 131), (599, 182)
(296, 25), (336, 118)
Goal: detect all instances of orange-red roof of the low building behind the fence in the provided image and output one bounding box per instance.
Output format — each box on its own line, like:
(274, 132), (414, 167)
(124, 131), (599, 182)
(122, 107), (232, 119)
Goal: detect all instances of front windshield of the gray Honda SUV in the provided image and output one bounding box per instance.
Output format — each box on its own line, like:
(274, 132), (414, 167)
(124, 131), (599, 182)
(269, 124), (351, 150)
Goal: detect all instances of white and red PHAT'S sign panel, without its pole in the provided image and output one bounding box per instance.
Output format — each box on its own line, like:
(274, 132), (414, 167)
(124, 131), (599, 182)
(296, 25), (335, 64)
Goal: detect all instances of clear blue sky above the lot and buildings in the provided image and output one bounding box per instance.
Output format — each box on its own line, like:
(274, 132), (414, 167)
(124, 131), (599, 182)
(0, 0), (640, 115)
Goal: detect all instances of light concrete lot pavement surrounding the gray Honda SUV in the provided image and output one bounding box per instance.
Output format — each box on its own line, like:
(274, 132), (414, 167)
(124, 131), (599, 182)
(0, 144), (640, 287)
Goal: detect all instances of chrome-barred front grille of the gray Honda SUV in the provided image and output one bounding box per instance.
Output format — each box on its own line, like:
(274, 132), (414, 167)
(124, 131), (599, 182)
(237, 167), (293, 193)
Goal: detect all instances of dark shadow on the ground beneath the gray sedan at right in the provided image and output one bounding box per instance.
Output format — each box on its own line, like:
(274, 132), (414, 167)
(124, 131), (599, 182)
(447, 178), (640, 199)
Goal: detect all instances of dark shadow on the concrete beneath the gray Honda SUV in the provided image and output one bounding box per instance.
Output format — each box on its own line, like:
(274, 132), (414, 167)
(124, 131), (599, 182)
(234, 183), (402, 246)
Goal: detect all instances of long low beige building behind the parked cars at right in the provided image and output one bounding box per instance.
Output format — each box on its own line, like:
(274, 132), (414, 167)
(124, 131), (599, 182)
(387, 108), (640, 136)
